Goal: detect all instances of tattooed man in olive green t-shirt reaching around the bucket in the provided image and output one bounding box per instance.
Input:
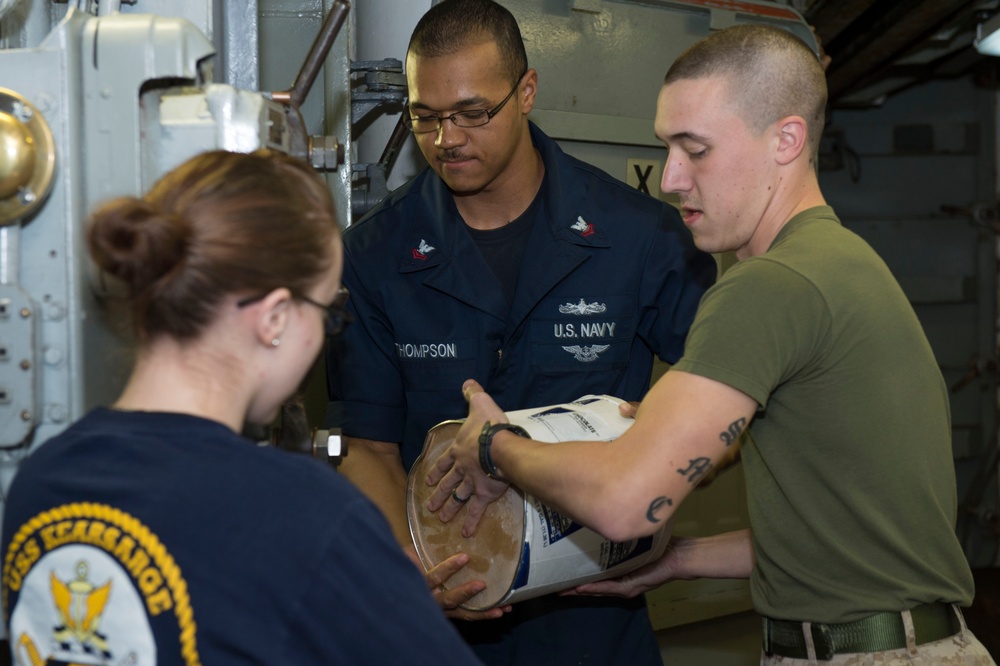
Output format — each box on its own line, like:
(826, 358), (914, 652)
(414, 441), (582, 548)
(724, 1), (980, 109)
(428, 26), (993, 664)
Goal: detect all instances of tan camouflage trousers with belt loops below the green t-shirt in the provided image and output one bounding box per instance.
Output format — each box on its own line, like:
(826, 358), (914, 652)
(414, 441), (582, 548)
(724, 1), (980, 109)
(760, 606), (996, 666)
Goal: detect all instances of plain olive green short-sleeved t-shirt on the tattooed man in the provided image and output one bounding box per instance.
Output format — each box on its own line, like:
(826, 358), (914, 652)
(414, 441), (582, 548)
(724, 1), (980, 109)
(674, 206), (973, 622)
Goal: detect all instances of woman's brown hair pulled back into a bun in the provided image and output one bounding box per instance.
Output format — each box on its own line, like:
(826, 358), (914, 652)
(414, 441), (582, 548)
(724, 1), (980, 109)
(87, 150), (340, 342)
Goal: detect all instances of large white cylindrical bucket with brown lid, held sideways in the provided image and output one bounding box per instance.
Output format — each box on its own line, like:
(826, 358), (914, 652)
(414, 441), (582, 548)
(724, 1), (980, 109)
(406, 395), (671, 610)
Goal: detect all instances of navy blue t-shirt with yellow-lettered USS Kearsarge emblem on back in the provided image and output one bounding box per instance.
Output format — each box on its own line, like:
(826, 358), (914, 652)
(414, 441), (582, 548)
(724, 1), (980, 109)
(3, 409), (477, 666)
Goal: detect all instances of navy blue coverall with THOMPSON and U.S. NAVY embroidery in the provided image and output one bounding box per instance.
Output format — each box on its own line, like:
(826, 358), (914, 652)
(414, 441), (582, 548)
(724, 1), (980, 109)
(328, 125), (716, 664)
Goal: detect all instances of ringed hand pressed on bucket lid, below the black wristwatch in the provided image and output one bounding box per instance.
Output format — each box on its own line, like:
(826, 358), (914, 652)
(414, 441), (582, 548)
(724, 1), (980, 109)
(427, 379), (510, 537)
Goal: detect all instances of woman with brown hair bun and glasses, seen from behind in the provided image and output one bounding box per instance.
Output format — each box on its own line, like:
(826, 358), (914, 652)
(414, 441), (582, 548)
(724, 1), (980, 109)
(2, 151), (484, 665)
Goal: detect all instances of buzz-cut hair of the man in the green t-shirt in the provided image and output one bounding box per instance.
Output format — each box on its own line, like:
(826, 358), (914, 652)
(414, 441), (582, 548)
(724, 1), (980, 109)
(664, 24), (827, 156)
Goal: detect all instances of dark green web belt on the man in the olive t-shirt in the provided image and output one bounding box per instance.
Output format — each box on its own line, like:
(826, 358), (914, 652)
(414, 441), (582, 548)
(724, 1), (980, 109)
(763, 603), (962, 661)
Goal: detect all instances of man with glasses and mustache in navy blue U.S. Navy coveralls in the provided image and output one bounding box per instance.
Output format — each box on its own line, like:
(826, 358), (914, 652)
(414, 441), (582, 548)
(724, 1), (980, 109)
(329, 0), (715, 665)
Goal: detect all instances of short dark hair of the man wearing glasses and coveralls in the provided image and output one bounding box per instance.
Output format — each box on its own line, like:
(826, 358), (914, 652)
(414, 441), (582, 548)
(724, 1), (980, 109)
(406, 0), (528, 83)
